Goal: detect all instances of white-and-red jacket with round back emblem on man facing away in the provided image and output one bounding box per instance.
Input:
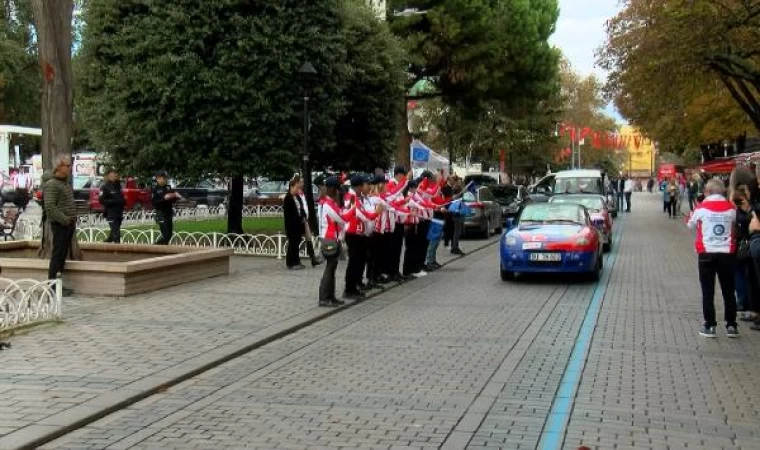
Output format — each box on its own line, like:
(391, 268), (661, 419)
(688, 195), (736, 254)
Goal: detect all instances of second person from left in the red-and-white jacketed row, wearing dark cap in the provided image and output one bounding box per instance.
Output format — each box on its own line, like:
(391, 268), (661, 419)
(343, 175), (382, 300)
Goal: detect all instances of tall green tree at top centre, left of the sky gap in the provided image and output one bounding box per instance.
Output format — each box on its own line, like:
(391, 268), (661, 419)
(391, 0), (559, 165)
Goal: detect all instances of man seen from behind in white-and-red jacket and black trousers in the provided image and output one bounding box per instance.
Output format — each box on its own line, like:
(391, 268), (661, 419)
(688, 179), (739, 338)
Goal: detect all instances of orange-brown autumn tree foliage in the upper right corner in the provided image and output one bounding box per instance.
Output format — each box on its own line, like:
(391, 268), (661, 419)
(599, 0), (760, 152)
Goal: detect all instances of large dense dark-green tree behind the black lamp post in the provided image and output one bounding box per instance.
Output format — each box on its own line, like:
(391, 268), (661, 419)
(81, 0), (348, 232)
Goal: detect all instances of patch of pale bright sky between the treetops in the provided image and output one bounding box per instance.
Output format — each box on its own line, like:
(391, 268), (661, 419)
(551, 0), (620, 119)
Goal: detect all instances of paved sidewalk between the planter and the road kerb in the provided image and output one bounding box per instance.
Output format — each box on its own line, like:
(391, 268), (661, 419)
(0, 234), (497, 449)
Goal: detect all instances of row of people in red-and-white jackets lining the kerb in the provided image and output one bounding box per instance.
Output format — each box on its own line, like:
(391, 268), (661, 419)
(318, 167), (467, 306)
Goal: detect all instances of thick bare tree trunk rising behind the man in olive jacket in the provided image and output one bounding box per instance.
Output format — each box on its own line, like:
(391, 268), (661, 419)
(32, 0), (74, 170)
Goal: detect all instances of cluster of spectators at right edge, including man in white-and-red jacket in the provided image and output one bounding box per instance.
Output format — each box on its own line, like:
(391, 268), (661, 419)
(687, 168), (760, 338)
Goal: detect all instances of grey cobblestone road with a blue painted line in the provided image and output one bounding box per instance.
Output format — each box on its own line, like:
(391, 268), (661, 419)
(11, 194), (760, 450)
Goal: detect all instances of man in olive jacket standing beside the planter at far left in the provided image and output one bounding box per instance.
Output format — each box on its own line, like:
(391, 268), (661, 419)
(43, 156), (77, 280)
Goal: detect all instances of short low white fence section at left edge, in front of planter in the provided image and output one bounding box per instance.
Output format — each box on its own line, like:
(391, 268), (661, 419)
(0, 278), (63, 331)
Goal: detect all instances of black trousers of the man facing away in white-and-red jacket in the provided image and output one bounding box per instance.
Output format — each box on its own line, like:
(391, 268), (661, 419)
(698, 253), (736, 327)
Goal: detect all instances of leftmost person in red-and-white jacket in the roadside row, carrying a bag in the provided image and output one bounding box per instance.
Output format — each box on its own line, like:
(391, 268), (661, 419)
(318, 177), (356, 306)
